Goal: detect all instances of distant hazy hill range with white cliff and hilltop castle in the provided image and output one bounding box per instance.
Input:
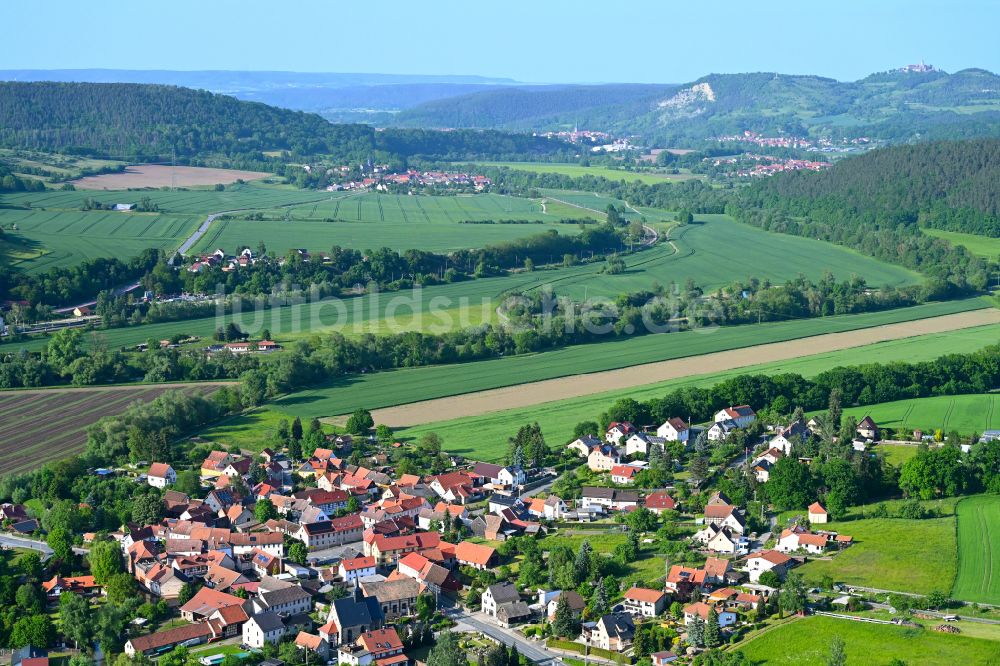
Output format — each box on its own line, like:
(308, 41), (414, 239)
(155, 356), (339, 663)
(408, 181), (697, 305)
(395, 69), (1000, 148)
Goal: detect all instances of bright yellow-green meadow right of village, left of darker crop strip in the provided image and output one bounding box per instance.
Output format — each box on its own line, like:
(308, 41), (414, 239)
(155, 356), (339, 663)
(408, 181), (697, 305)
(798, 499), (958, 594)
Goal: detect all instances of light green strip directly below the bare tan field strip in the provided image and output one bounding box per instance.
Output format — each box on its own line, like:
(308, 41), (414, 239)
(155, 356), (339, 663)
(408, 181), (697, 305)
(400, 325), (1000, 460)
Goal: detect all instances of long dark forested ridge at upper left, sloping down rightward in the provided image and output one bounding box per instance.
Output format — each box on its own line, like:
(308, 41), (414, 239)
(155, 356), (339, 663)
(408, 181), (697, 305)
(0, 82), (571, 162)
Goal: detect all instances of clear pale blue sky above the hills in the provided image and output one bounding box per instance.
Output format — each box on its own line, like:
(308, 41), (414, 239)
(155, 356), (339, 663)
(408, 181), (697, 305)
(0, 0), (1000, 83)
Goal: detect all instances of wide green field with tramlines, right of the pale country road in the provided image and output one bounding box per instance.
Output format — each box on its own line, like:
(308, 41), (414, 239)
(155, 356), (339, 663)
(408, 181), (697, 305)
(195, 193), (588, 254)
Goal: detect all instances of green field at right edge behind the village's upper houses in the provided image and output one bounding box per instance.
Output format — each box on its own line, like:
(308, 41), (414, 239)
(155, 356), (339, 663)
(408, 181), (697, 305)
(832, 393), (1000, 435)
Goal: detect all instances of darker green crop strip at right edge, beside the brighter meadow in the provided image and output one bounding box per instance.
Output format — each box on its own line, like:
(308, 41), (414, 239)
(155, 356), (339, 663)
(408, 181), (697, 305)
(951, 495), (1000, 604)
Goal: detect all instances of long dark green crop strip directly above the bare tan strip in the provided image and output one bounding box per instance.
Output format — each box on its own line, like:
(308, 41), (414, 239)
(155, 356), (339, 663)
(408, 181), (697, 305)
(262, 299), (983, 418)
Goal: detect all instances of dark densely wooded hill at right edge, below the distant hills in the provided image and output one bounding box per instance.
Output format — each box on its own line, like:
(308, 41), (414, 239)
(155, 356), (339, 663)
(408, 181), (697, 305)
(751, 139), (1000, 237)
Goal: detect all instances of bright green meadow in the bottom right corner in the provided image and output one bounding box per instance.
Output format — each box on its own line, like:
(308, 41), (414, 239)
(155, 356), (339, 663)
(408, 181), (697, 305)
(735, 616), (1000, 666)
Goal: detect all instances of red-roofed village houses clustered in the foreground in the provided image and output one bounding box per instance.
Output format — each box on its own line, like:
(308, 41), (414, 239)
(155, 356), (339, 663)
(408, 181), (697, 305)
(0, 405), (908, 666)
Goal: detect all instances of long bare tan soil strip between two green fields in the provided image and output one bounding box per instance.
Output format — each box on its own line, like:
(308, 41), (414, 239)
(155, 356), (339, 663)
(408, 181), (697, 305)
(372, 308), (1000, 428)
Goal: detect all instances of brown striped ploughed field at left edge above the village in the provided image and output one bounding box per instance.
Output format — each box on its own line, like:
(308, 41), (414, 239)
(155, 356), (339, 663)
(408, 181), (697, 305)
(0, 383), (225, 475)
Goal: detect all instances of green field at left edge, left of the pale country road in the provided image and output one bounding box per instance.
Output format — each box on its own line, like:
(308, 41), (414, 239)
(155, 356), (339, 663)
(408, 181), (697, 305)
(0, 209), (200, 273)
